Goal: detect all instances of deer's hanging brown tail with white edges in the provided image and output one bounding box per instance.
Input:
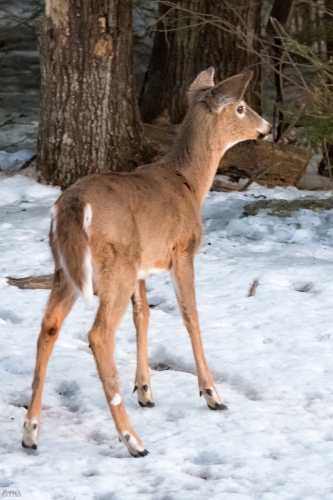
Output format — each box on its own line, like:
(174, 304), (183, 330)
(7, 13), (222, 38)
(50, 197), (94, 309)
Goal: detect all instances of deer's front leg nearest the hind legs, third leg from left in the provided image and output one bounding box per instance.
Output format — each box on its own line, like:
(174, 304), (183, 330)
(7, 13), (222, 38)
(132, 280), (155, 408)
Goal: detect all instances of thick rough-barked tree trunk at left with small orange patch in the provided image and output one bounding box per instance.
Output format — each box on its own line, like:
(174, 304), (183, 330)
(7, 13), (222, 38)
(37, 0), (142, 187)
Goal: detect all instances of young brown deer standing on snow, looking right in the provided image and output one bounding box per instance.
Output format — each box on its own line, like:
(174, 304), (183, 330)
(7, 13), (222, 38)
(22, 68), (270, 457)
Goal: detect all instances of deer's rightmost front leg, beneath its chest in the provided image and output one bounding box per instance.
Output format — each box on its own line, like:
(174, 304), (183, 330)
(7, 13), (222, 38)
(171, 251), (227, 410)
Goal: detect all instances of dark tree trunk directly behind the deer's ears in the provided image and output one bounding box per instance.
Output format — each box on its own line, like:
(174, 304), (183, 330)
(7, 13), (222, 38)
(139, 0), (261, 123)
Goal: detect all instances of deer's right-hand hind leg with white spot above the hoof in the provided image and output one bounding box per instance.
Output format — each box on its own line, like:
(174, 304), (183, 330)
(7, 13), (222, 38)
(89, 264), (148, 457)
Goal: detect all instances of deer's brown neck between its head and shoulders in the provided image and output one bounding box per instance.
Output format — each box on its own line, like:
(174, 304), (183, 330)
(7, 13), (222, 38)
(165, 108), (228, 204)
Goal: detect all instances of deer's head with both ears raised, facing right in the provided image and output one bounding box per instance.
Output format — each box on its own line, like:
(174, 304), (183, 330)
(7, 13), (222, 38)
(189, 67), (271, 153)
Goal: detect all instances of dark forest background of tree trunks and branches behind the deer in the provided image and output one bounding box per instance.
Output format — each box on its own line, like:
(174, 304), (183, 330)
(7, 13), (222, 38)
(0, 0), (333, 188)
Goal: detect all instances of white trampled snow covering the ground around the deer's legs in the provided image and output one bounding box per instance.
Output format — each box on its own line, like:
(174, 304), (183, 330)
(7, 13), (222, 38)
(0, 174), (333, 500)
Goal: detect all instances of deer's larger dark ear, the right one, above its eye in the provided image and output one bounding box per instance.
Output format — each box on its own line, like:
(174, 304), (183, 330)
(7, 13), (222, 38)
(205, 70), (253, 113)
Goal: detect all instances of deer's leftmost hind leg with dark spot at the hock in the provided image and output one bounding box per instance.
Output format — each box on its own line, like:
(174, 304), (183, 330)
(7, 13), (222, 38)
(22, 269), (77, 449)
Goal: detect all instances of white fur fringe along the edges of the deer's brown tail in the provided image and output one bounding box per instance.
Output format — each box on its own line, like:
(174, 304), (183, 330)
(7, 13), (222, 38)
(51, 203), (94, 309)
